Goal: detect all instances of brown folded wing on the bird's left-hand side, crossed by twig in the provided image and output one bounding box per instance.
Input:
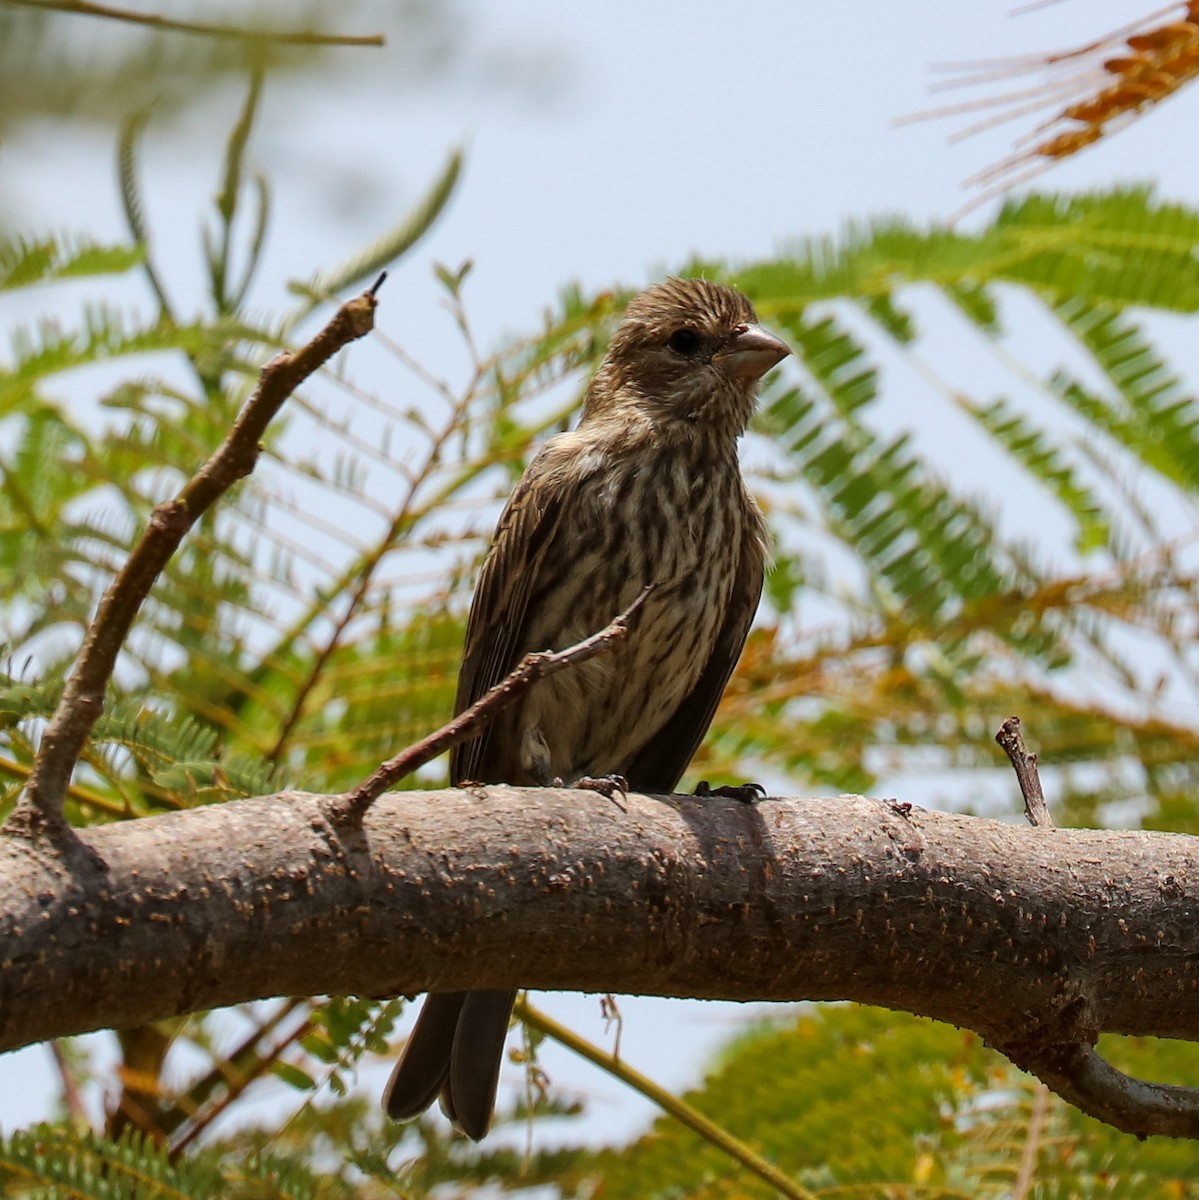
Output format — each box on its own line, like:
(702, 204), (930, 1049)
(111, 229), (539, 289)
(450, 451), (565, 784)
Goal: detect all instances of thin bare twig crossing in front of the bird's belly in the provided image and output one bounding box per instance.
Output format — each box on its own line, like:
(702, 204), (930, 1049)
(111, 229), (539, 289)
(329, 583), (654, 824)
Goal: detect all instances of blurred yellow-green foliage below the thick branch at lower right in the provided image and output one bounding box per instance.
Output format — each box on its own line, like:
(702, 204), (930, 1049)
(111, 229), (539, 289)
(576, 1004), (1199, 1200)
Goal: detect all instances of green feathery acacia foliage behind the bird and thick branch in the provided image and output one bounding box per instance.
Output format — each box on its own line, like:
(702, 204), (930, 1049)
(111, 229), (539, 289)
(7, 77), (1199, 1195)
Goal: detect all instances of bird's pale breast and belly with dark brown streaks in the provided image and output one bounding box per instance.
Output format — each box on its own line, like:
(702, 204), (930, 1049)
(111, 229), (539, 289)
(511, 461), (756, 781)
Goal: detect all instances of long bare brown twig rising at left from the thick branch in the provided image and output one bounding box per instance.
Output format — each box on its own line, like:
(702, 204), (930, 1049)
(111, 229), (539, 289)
(6, 276), (384, 835)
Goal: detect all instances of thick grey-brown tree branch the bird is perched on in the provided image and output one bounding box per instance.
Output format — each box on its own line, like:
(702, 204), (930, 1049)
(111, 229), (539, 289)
(0, 787), (1199, 1136)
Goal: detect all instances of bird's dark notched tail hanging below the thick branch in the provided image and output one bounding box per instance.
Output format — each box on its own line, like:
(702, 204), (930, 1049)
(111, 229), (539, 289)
(383, 991), (516, 1141)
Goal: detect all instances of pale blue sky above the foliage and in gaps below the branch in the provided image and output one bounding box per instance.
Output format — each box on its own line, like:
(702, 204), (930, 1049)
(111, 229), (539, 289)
(0, 0), (1199, 1152)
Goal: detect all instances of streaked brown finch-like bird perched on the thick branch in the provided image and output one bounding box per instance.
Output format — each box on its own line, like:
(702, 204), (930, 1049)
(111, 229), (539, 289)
(384, 278), (790, 1141)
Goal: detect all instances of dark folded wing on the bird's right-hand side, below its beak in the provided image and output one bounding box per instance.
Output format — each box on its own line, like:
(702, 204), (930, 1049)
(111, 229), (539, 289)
(623, 536), (765, 792)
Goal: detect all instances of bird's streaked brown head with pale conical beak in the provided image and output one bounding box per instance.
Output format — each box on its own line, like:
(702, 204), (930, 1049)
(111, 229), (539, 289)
(583, 278), (791, 439)
